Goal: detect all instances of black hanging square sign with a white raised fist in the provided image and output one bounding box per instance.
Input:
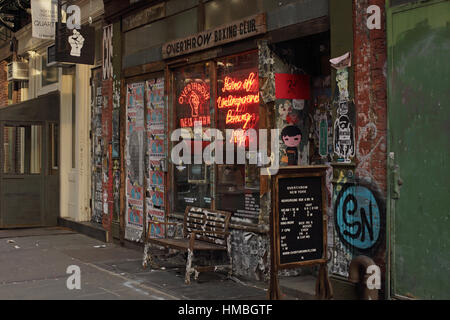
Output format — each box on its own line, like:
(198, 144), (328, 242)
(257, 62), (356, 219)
(55, 23), (95, 65)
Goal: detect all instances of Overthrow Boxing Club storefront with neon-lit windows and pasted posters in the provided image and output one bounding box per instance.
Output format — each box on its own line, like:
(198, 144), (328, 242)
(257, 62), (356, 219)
(103, 0), (384, 298)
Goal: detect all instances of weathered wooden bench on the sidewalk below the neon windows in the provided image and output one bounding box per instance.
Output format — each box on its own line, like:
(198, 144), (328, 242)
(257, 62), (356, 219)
(142, 207), (232, 284)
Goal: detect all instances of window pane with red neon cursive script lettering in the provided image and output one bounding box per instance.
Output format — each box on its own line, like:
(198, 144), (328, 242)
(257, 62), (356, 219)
(216, 52), (259, 222)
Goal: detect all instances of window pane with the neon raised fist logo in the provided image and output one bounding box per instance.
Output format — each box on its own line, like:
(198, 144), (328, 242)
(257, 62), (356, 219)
(173, 63), (211, 212)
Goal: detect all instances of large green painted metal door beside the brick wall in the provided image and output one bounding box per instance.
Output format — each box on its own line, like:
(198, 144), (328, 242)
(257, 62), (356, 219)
(387, 0), (450, 299)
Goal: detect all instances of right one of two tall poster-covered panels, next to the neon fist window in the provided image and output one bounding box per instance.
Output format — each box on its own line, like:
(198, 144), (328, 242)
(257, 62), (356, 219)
(145, 78), (167, 237)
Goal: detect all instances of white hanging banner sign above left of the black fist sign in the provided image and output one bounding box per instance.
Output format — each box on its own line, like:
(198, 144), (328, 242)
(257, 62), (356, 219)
(30, 0), (58, 40)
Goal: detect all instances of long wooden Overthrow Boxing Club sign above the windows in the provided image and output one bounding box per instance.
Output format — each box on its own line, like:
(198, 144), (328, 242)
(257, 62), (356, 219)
(162, 13), (267, 59)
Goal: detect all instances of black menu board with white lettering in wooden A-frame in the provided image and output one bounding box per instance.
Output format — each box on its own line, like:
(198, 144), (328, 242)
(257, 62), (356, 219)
(272, 166), (326, 268)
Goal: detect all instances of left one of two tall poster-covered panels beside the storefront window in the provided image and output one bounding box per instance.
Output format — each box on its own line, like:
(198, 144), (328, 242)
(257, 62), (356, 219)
(125, 82), (145, 241)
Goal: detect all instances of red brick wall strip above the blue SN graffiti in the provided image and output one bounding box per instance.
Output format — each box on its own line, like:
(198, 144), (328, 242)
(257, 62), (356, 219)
(354, 0), (387, 196)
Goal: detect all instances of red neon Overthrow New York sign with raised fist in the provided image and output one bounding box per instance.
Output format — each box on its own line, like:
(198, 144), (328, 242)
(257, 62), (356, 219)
(178, 81), (211, 128)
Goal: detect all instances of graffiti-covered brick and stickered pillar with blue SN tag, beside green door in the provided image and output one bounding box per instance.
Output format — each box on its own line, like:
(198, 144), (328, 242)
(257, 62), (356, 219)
(329, 0), (387, 290)
